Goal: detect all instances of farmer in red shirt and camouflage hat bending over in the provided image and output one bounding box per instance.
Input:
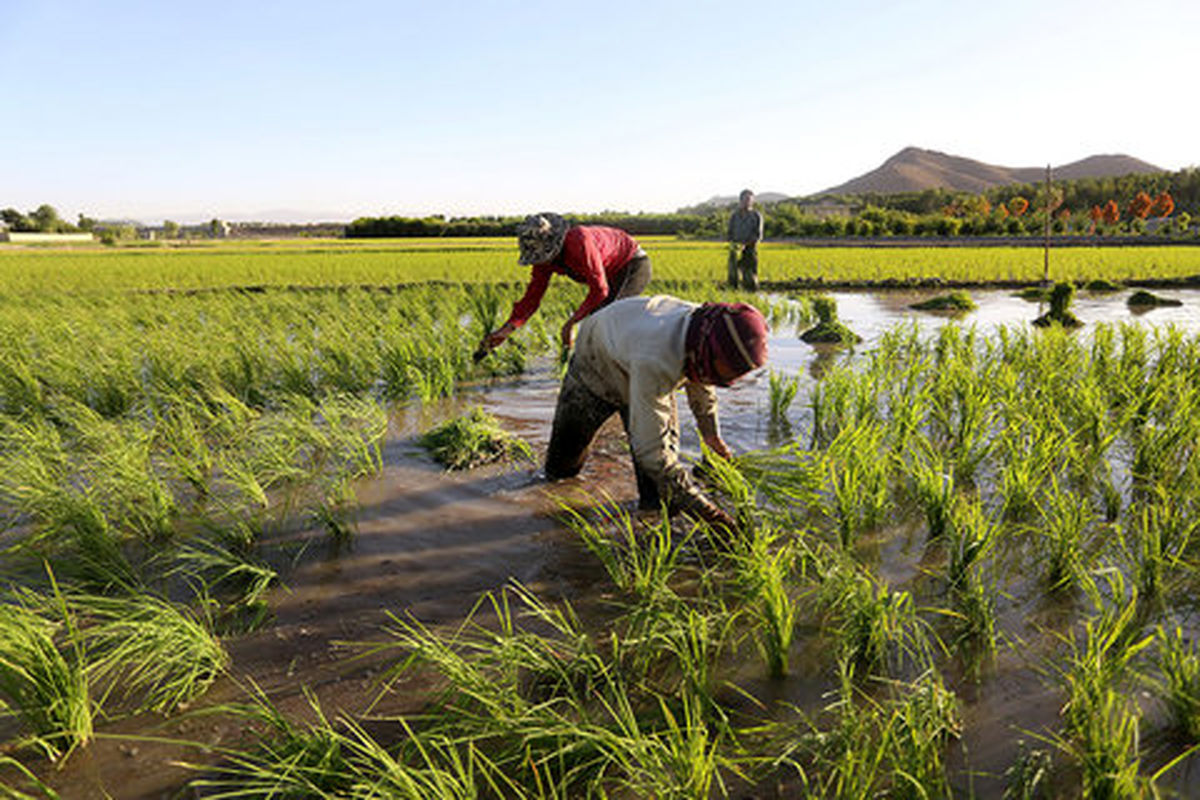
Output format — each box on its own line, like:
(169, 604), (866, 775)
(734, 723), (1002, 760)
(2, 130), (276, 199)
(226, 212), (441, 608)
(480, 212), (650, 351)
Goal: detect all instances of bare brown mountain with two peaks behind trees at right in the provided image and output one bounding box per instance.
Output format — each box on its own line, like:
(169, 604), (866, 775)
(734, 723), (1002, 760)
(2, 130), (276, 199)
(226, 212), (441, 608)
(818, 148), (1163, 194)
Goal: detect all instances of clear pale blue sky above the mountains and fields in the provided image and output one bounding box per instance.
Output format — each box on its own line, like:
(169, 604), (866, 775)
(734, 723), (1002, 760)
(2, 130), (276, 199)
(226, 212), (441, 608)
(0, 0), (1200, 221)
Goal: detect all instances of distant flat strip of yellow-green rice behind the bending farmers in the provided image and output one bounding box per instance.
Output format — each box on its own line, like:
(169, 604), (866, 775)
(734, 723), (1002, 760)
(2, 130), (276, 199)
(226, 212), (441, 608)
(11, 244), (1200, 297)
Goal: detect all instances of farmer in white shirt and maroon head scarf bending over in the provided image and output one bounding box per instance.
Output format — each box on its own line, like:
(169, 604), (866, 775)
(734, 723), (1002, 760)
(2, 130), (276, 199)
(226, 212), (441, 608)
(546, 295), (767, 531)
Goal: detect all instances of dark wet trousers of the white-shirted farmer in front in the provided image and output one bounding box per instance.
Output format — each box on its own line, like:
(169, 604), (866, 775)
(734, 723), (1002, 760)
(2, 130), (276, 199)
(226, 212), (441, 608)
(546, 360), (679, 509)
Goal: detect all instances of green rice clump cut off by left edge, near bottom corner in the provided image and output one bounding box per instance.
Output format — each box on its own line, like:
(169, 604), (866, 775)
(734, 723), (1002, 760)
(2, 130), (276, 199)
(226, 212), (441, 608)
(0, 572), (95, 758)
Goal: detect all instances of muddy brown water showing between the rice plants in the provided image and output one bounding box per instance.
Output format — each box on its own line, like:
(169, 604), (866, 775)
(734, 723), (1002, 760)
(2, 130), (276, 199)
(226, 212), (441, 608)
(25, 291), (1200, 799)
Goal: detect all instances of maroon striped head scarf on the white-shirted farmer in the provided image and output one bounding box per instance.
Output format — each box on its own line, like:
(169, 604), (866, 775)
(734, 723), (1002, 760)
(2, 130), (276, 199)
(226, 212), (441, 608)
(684, 302), (767, 386)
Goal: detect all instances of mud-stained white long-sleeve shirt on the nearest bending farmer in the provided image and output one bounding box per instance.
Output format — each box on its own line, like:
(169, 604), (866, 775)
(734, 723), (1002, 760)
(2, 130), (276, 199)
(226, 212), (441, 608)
(575, 295), (719, 482)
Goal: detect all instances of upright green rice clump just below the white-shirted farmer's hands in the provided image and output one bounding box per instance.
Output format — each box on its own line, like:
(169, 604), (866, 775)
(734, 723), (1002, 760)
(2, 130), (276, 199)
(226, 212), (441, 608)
(734, 528), (799, 679)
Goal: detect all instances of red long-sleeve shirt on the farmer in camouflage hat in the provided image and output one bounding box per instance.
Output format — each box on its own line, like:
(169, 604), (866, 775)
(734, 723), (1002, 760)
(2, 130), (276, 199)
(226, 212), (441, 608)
(509, 225), (638, 327)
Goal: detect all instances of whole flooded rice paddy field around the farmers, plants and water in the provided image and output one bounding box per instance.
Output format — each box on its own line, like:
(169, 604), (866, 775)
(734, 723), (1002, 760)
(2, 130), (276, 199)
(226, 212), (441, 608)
(0, 239), (1200, 799)
